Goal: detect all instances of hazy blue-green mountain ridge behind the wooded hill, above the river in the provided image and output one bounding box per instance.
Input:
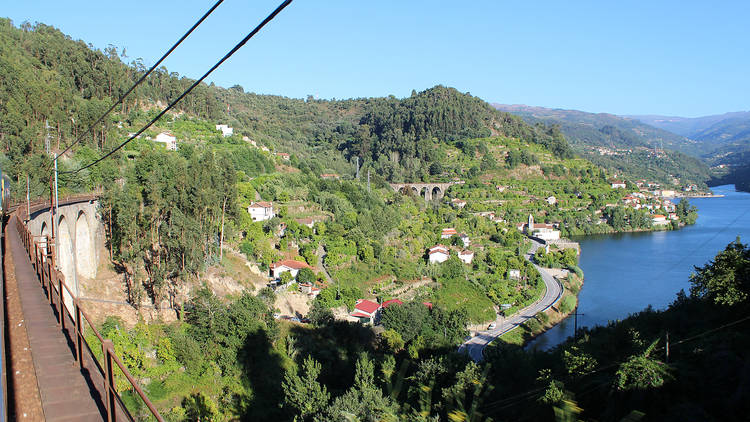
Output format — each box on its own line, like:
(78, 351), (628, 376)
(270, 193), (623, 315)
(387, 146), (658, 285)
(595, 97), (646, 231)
(492, 104), (710, 183)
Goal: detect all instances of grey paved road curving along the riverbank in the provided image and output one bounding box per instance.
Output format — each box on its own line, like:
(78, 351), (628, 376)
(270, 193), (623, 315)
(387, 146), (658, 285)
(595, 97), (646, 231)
(458, 240), (562, 362)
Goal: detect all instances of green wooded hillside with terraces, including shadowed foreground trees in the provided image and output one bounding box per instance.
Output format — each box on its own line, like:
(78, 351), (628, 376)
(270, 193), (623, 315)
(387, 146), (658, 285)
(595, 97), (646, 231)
(0, 19), (750, 421)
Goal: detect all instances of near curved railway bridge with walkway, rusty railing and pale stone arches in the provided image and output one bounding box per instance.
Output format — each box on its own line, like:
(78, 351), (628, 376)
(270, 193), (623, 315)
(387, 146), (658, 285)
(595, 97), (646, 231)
(0, 196), (162, 421)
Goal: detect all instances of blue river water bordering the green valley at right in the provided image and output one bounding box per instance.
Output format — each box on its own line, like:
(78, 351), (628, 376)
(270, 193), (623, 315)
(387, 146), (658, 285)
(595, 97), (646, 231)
(527, 185), (750, 350)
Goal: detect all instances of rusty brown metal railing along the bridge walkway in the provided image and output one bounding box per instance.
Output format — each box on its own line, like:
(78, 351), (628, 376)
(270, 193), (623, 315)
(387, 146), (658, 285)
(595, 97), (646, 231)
(14, 205), (163, 422)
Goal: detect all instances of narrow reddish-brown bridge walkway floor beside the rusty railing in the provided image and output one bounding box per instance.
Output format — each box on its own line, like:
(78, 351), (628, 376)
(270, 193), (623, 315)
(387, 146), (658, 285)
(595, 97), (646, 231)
(6, 219), (106, 421)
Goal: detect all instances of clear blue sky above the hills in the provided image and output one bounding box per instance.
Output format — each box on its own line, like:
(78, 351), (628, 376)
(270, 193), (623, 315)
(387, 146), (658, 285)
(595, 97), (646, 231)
(0, 0), (750, 117)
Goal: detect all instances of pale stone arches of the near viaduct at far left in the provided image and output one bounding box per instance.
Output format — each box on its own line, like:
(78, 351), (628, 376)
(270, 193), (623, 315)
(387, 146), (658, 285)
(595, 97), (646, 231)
(27, 197), (105, 295)
